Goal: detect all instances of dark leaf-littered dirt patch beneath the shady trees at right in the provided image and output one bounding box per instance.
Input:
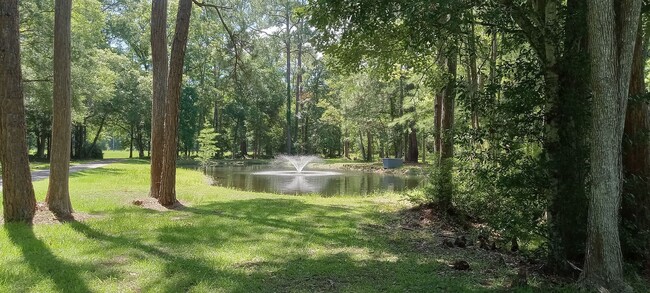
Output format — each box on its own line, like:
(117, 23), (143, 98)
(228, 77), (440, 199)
(392, 206), (556, 287)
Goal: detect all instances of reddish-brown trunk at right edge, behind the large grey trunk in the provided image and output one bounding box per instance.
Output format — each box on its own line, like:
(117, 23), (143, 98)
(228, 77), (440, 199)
(621, 17), (650, 269)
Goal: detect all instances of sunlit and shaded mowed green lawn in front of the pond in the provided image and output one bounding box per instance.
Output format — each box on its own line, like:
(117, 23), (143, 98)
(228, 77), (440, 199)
(0, 160), (576, 292)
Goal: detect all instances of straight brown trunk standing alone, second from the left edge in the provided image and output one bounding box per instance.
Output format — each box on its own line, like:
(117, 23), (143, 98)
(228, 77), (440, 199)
(45, 0), (72, 218)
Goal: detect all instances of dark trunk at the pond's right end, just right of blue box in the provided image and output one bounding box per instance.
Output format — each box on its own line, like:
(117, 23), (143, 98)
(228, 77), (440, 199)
(437, 46), (458, 211)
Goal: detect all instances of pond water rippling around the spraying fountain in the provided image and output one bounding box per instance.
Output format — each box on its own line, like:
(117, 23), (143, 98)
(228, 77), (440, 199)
(205, 165), (422, 196)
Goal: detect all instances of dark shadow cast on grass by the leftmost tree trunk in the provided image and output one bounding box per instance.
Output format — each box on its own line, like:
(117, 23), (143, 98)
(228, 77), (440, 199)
(4, 223), (98, 292)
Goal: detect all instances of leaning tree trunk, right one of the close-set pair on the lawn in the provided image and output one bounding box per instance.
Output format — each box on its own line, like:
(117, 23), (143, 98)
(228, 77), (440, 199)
(158, 0), (192, 206)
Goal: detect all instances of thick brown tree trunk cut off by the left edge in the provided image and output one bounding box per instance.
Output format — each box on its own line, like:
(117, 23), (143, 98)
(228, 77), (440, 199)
(0, 0), (36, 223)
